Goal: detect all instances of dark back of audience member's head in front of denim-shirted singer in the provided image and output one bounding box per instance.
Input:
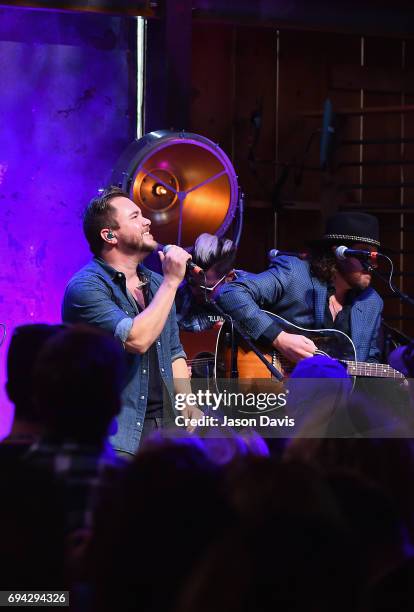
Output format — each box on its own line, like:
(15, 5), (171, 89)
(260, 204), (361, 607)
(33, 324), (126, 442)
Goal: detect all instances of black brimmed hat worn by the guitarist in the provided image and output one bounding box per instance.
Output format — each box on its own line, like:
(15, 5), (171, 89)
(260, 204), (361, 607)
(307, 212), (381, 247)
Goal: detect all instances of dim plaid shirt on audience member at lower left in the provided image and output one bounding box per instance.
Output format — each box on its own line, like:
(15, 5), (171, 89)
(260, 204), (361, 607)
(23, 439), (126, 533)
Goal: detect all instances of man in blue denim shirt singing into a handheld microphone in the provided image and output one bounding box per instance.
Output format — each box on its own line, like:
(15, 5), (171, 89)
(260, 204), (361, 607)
(62, 187), (202, 454)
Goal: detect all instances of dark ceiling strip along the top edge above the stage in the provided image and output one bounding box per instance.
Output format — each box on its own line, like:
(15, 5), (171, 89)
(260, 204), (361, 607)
(0, 0), (414, 37)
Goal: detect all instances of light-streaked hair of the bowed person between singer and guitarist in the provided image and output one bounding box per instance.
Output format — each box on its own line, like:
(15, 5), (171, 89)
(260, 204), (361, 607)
(192, 233), (237, 276)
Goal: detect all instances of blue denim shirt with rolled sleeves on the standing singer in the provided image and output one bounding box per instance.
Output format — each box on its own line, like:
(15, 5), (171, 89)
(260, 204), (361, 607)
(62, 257), (186, 453)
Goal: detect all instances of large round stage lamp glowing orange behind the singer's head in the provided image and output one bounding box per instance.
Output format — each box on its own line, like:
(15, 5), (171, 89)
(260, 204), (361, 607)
(112, 131), (239, 246)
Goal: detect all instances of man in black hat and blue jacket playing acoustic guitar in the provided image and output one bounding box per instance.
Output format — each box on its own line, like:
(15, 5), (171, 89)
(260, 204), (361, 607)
(217, 212), (383, 362)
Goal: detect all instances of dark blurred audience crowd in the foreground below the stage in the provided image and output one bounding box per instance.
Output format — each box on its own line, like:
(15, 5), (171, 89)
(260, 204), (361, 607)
(0, 325), (414, 612)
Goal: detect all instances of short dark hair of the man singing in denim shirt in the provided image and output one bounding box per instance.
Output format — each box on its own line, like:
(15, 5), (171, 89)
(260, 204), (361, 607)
(83, 185), (130, 255)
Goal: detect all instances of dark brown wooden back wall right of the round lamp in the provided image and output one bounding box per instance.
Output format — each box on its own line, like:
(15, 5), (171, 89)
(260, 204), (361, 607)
(191, 22), (414, 335)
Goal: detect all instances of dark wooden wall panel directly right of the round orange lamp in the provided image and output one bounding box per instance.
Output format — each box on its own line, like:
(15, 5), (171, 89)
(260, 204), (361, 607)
(233, 27), (277, 272)
